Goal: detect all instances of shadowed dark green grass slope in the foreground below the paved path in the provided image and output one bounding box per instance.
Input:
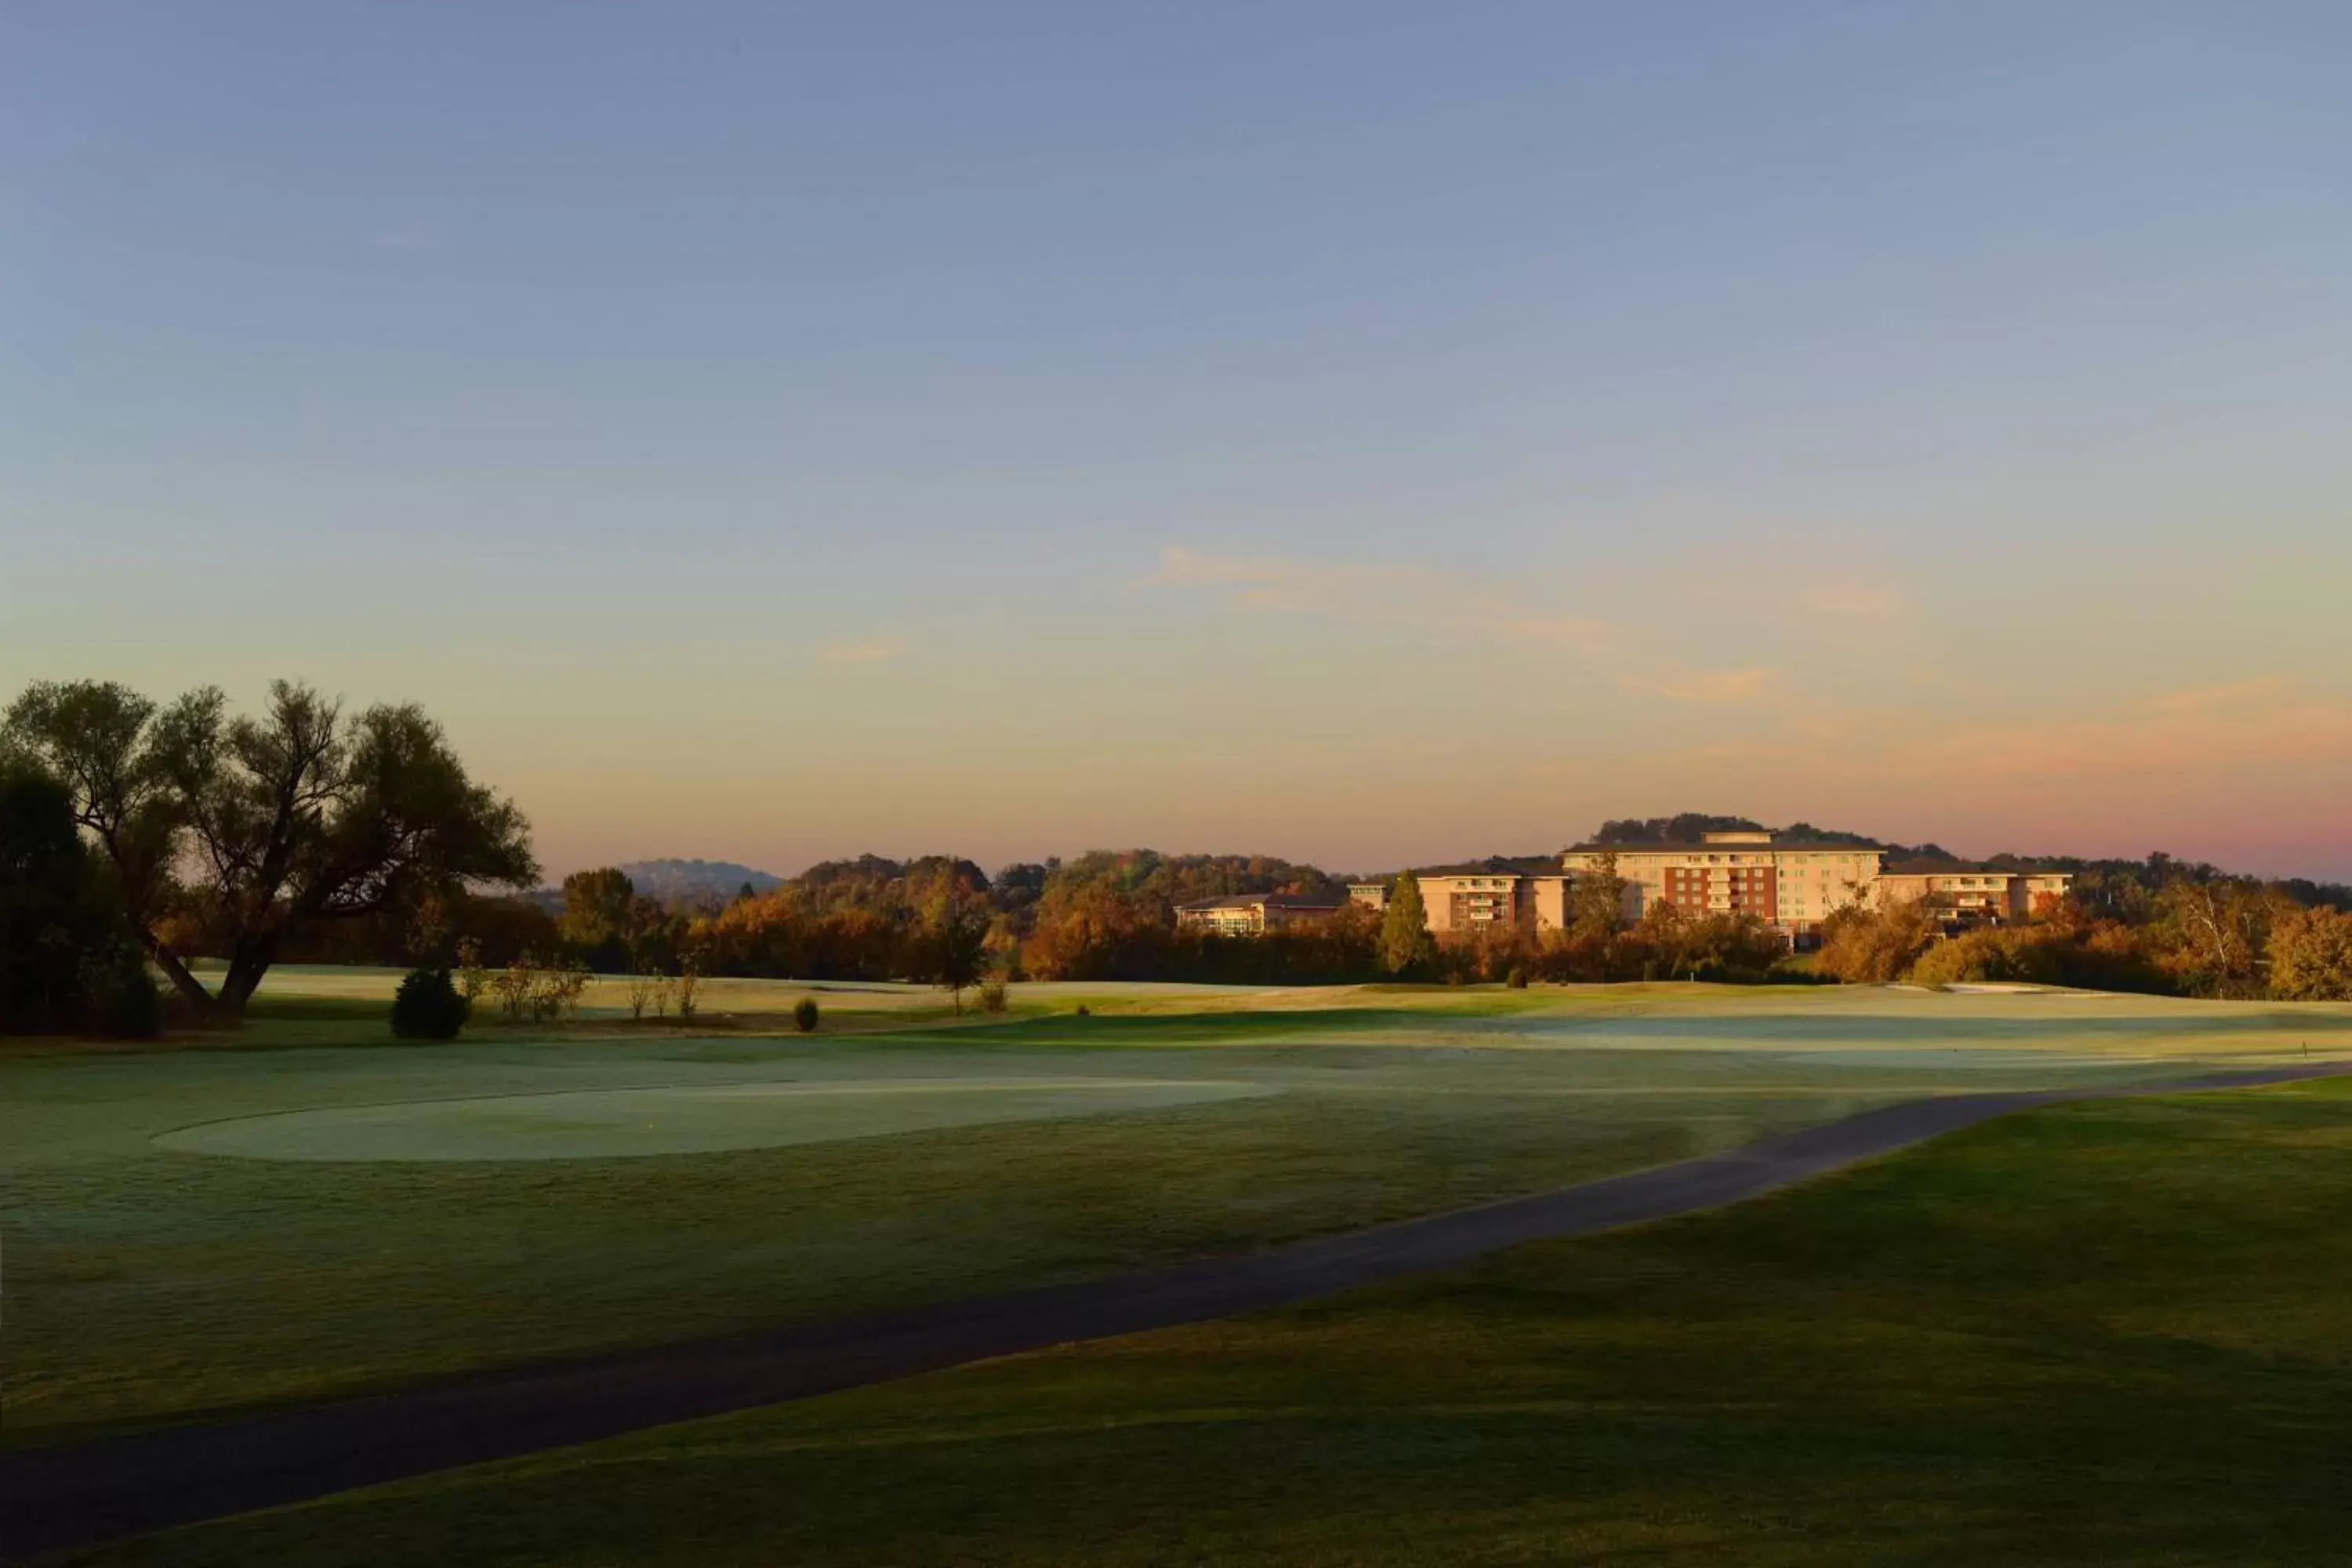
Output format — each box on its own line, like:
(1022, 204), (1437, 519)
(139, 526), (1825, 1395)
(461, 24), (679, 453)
(73, 1083), (2352, 1566)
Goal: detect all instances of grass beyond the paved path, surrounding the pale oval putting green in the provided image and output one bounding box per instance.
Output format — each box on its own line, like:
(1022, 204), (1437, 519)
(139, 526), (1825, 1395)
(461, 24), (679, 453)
(0, 971), (2352, 1443)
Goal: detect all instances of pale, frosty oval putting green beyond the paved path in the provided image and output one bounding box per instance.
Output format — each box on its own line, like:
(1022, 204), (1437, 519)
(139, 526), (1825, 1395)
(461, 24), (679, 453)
(155, 1079), (1277, 1161)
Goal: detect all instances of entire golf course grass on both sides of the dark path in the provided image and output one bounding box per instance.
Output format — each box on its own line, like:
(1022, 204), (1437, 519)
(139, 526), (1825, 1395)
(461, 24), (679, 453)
(0, 968), (2352, 1563)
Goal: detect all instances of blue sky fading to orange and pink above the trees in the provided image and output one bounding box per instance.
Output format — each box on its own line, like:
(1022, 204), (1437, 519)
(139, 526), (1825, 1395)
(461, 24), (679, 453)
(0, 0), (2352, 877)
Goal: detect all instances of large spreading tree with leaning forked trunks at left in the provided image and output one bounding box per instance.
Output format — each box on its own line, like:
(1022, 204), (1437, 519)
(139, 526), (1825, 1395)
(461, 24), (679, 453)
(5, 682), (539, 1013)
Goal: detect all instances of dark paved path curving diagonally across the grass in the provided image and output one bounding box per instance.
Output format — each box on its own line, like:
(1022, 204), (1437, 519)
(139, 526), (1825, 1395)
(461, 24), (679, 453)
(0, 1062), (2352, 1559)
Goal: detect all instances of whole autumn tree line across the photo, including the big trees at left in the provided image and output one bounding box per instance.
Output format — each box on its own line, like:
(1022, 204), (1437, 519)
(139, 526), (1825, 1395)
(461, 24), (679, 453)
(0, 682), (2352, 1032)
